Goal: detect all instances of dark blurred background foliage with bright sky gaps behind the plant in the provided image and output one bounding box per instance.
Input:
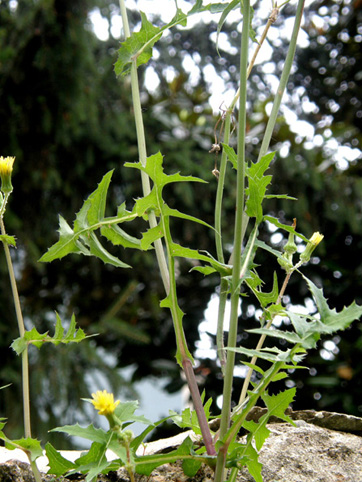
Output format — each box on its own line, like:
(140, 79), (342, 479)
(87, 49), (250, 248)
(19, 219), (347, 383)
(0, 0), (362, 446)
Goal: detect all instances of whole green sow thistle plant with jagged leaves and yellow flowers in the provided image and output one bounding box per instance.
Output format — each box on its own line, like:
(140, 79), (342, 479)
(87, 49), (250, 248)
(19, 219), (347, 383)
(0, 0), (362, 482)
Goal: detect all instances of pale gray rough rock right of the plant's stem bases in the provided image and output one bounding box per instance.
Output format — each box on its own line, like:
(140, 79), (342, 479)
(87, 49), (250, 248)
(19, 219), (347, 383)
(238, 420), (362, 482)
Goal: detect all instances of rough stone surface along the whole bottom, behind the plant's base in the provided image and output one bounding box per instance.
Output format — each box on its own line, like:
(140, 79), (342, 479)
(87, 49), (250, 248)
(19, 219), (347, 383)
(0, 420), (362, 482)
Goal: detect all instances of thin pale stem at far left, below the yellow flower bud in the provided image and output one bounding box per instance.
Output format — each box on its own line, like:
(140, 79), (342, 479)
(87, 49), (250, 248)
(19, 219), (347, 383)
(0, 216), (31, 438)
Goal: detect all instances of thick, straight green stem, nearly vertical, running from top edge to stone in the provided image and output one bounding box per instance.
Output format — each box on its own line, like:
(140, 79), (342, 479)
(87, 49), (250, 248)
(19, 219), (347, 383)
(215, 0), (250, 482)
